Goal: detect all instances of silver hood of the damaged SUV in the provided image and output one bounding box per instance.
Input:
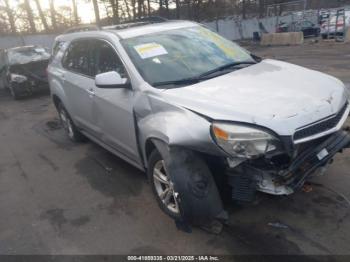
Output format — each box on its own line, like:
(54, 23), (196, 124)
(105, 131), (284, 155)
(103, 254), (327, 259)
(163, 59), (347, 135)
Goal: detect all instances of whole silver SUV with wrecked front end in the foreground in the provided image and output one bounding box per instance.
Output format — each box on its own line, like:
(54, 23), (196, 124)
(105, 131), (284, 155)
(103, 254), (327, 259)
(48, 21), (350, 229)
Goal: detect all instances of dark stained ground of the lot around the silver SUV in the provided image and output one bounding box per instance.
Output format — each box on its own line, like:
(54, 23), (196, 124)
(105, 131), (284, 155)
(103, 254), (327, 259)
(0, 43), (350, 254)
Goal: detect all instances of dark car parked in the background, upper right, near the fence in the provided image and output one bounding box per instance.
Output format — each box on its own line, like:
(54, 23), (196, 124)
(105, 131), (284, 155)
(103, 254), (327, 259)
(276, 21), (320, 37)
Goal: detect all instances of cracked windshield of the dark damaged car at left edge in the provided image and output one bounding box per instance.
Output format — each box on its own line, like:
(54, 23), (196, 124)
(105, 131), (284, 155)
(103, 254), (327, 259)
(8, 47), (50, 65)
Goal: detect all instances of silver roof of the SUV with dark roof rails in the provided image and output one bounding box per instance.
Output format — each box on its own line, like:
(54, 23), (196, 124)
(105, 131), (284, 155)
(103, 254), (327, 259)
(56, 20), (198, 41)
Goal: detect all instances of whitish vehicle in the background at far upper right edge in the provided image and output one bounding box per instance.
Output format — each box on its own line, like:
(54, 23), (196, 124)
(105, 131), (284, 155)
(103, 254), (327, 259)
(321, 11), (350, 39)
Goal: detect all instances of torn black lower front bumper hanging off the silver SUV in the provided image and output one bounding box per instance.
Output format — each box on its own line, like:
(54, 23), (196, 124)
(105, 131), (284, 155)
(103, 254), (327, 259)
(227, 130), (350, 201)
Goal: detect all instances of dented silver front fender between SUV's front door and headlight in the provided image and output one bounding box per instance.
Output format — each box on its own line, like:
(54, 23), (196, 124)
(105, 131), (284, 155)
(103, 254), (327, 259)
(134, 94), (224, 167)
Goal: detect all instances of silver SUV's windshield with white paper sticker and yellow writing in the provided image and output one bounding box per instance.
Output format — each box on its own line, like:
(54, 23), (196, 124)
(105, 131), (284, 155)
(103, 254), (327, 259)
(121, 26), (254, 85)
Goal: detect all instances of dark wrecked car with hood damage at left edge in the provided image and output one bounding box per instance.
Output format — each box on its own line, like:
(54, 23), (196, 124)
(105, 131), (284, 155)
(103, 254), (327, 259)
(0, 46), (50, 99)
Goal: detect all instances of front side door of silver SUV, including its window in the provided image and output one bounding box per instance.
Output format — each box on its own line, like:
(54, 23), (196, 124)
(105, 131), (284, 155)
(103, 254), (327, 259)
(93, 40), (140, 163)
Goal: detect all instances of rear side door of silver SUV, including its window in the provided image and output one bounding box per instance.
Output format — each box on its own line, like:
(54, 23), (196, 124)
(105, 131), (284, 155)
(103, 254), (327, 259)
(62, 39), (101, 137)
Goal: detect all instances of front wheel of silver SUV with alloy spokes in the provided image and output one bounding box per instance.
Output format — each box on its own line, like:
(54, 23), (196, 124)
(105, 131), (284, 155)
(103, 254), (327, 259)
(147, 150), (181, 219)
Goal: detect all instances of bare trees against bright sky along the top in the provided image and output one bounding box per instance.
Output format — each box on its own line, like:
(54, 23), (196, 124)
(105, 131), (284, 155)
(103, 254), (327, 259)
(0, 0), (350, 34)
